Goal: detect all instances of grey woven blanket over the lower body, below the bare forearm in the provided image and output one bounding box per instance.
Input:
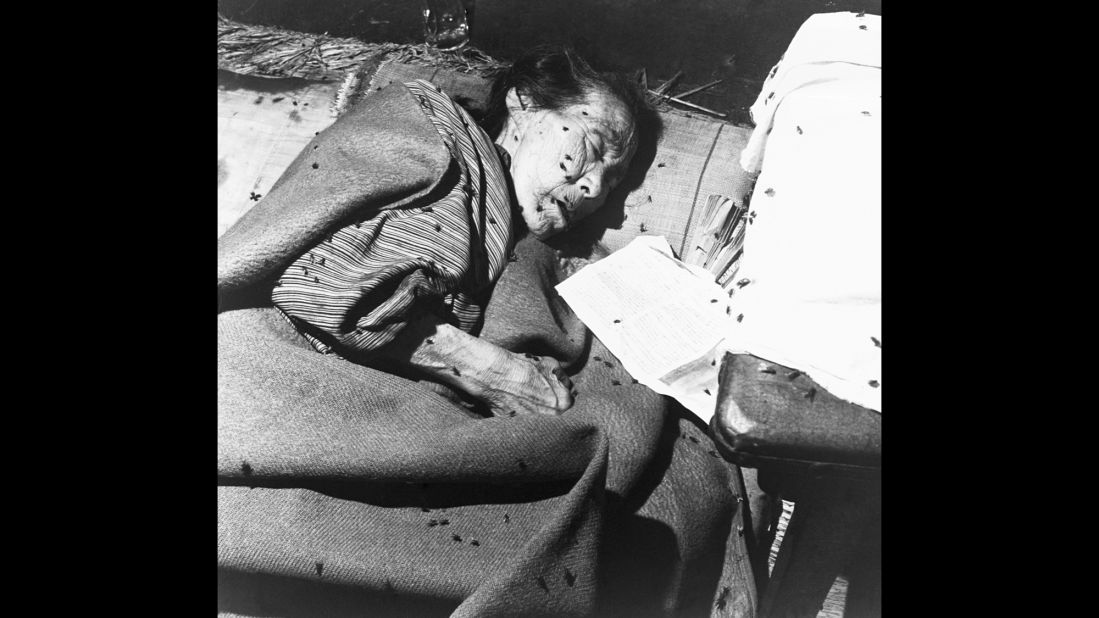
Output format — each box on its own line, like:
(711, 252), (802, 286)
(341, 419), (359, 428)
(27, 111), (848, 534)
(218, 233), (755, 616)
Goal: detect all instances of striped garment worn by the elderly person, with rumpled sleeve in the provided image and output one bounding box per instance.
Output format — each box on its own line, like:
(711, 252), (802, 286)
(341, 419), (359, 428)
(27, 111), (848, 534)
(271, 79), (513, 353)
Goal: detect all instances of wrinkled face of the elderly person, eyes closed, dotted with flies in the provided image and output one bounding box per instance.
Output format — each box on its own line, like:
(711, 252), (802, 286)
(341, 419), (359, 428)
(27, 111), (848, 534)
(503, 92), (636, 239)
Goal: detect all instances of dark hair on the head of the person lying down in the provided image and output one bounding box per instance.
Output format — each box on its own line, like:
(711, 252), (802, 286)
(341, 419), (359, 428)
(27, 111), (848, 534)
(481, 46), (656, 137)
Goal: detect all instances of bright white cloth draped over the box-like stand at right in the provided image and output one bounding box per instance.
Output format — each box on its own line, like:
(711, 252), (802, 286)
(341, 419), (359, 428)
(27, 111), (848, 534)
(726, 13), (881, 411)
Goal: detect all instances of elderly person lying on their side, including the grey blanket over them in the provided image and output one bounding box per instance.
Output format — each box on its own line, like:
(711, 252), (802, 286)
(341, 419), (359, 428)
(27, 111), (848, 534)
(218, 51), (755, 616)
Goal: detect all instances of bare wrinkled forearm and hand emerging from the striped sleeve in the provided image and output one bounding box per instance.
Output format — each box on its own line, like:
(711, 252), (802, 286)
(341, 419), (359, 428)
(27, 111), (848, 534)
(379, 316), (573, 416)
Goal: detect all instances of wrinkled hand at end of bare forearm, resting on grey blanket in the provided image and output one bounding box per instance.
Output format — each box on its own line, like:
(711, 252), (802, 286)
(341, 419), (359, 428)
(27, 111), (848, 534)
(478, 352), (573, 416)
